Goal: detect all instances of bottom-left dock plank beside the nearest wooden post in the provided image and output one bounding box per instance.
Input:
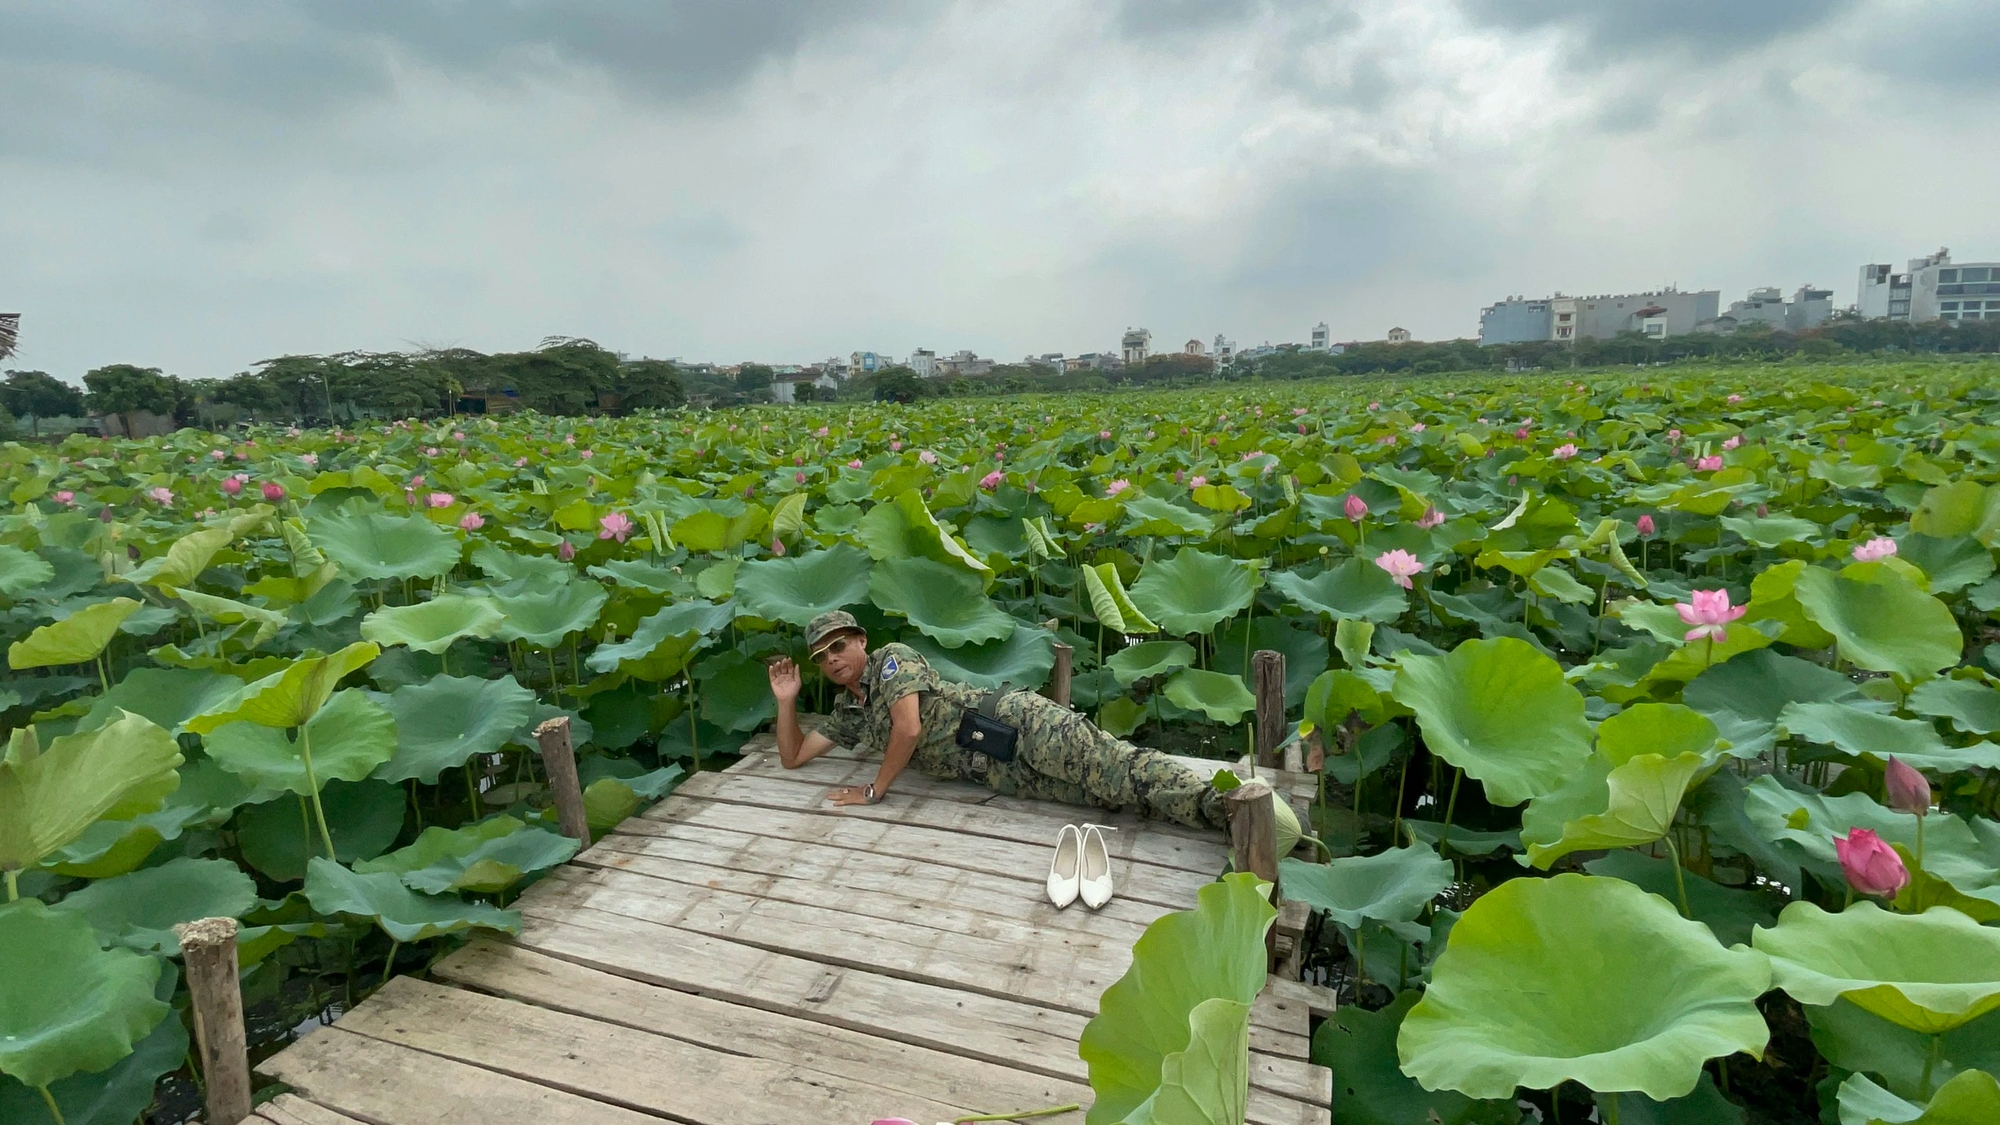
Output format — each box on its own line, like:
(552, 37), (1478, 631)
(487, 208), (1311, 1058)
(256, 1025), (660, 1125)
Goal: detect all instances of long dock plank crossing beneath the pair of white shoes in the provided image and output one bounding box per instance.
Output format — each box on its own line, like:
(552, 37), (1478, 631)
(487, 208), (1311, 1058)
(620, 775), (1214, 911)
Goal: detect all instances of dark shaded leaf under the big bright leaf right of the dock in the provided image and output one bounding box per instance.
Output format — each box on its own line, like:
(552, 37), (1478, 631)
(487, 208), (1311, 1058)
(1312, 989), (1520, 1125)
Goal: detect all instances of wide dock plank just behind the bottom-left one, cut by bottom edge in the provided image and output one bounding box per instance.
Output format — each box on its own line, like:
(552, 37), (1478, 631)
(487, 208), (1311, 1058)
(340, 977), (980, 1125)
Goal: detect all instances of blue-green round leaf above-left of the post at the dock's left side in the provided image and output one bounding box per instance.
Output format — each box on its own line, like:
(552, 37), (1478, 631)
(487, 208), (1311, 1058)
(376, 677), (534, 785)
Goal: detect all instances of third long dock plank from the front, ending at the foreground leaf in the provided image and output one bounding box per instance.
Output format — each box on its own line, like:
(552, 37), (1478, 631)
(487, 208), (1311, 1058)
(434, 941), (1090, 1113)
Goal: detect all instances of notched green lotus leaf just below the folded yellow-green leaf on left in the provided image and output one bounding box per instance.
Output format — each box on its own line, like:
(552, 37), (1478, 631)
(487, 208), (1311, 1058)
(204, 689), (396, 797)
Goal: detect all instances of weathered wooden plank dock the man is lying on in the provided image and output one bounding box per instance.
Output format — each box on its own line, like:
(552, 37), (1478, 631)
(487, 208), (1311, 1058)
(252, 737), (1332, 1125)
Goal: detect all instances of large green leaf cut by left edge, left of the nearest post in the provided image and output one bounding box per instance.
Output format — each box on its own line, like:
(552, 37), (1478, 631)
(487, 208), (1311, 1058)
(0, 899), (172, 1087)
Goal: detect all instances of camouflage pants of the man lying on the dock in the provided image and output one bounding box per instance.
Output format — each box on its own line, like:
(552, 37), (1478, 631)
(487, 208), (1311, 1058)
(940, 691), (1228, 829)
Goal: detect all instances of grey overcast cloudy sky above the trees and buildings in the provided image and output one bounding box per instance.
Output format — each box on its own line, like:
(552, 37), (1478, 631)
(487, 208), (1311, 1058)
(0, 0), (2000, 380)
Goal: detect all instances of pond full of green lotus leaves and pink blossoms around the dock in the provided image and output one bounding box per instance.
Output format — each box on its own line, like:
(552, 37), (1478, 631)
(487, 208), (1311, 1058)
(0, 364), (2000, 1125)
